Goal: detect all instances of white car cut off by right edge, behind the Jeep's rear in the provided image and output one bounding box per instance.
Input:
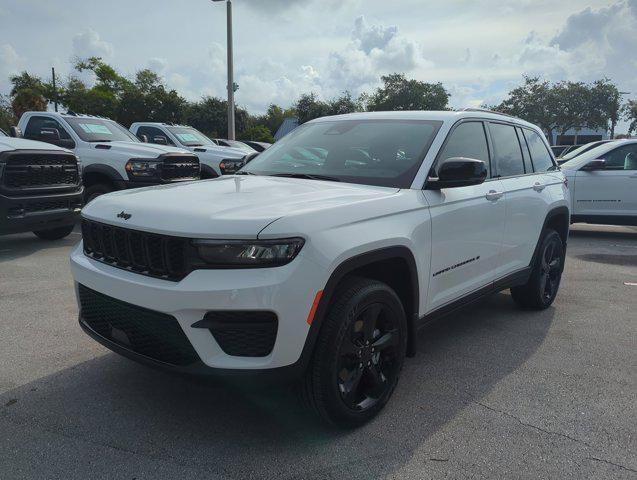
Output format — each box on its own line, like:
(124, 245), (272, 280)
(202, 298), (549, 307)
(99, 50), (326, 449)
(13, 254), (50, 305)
(561, 140), (637, 225)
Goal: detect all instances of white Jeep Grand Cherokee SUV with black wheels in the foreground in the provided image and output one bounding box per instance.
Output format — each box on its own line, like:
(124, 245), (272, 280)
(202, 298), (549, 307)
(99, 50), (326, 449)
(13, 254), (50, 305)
(71, 111), (569, 426)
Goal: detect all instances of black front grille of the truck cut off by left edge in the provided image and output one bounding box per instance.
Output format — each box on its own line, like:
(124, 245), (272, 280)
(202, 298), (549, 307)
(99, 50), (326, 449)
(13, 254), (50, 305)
(2, 151), (79, 190)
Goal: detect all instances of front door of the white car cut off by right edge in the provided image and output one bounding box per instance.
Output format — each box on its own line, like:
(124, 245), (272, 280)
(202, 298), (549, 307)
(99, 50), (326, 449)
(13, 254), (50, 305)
(573, 143), (637, 217)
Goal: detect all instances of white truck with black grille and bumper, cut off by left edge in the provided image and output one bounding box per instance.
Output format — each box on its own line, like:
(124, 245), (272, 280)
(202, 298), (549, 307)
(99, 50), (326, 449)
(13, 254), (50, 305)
(0, 131), (83, 240)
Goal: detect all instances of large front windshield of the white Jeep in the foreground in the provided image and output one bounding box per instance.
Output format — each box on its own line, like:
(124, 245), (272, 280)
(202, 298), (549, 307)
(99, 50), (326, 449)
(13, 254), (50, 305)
(240, 120), (442, 188)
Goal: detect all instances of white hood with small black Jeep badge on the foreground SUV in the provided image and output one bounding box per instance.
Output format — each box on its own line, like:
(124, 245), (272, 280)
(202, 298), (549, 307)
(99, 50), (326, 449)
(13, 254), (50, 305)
(82, 175), (399, 238)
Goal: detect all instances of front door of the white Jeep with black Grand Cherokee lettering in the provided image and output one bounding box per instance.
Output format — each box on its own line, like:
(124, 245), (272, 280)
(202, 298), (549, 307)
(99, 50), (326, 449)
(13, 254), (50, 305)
(423, 120), (505, 311)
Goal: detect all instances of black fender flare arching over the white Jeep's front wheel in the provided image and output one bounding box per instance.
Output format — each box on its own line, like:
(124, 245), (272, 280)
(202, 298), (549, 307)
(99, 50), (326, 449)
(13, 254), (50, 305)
(299, 245), (420, 370)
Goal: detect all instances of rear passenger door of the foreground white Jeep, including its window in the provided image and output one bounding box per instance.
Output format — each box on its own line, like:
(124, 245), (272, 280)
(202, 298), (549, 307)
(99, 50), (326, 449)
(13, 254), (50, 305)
(489, 122), (552, 279)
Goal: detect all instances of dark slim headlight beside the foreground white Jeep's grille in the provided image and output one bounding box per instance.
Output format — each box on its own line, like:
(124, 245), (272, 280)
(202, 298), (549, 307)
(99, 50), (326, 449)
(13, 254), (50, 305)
(193, 238), (305, 268)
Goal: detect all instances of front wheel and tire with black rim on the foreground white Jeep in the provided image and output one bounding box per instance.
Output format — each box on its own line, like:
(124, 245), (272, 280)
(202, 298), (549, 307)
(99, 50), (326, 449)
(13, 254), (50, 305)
(304, 278), (407, 428)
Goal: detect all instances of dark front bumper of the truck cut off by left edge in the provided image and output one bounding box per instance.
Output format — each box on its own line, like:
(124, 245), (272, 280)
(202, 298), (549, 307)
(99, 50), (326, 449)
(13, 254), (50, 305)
(0, 188), (84, 235)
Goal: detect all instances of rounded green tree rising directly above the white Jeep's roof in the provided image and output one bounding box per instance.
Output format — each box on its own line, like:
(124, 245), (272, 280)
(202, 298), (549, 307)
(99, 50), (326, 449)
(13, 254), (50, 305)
(363, 73), (450, 111)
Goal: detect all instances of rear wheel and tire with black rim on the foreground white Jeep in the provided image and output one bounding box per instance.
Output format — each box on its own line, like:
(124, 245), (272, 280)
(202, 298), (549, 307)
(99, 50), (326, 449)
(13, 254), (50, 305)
(511, 228), (565, 310)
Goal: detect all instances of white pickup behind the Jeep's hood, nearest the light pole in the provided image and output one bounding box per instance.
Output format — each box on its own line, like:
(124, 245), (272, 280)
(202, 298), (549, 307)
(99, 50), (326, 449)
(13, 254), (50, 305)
(130, 122), (246, 178)
